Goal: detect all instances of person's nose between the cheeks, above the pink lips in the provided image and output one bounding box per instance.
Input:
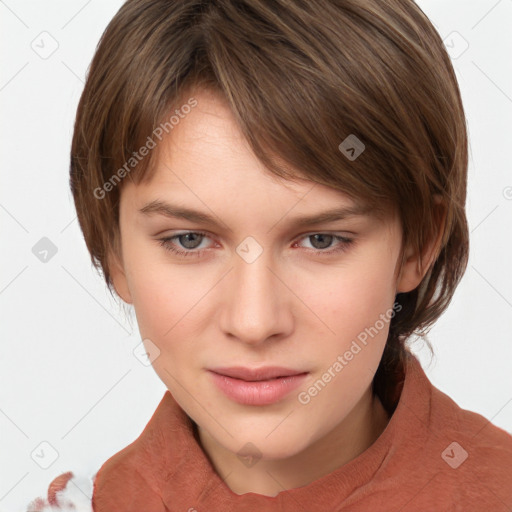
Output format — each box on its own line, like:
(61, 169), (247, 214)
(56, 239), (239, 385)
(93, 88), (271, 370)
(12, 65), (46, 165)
(220, 246), (294, 345)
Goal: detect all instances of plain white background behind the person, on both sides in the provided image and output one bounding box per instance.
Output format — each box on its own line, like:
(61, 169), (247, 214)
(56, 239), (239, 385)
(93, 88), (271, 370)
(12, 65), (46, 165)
(0, 0), (512, 512)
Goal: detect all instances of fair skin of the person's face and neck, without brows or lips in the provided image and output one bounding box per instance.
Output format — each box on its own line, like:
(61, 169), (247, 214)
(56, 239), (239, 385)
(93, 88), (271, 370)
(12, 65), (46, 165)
(111, 87), (439, 496)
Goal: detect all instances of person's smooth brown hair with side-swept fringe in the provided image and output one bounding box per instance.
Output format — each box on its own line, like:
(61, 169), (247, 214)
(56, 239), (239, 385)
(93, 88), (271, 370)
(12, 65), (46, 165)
(70, 0), (469, 409)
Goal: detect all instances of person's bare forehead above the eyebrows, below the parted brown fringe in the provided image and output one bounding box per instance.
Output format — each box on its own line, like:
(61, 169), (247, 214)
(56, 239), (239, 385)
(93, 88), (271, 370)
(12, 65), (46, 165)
(128, 89), (350, 202)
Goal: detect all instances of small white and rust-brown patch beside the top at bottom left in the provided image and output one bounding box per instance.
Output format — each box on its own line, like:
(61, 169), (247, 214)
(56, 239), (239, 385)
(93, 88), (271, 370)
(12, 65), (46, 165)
(26, 471), (95, 512)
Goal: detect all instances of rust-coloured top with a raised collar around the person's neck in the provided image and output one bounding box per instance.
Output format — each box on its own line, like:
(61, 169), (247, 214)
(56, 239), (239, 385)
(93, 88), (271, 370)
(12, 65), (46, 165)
(29, 355), (512, 512)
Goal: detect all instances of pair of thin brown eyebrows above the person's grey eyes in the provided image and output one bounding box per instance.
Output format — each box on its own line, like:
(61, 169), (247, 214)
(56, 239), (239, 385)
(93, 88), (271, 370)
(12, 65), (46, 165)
(139, 199), (371, 228)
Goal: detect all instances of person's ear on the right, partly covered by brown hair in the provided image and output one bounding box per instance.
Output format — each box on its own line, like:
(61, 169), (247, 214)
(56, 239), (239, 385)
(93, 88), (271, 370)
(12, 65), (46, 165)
(396, 195), (446, 293)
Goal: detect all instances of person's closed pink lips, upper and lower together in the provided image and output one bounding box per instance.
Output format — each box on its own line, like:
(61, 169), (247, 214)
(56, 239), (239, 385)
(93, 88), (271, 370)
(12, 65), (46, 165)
(210, 372), (308, 405)
